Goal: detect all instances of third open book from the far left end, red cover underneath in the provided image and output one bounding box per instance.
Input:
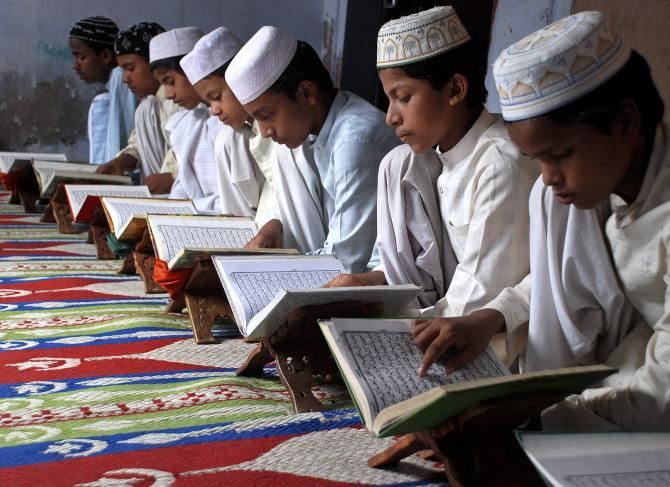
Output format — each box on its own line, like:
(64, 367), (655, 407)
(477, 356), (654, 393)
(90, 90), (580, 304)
(64, 184), (151, 223)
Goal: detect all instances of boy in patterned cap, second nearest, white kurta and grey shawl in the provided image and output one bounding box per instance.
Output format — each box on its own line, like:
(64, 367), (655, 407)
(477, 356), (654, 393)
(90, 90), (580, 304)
(322, 7), (538, 316)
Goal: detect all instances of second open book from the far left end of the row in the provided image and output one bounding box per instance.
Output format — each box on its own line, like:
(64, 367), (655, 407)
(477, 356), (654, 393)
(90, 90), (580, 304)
(33, 159), (132, 198)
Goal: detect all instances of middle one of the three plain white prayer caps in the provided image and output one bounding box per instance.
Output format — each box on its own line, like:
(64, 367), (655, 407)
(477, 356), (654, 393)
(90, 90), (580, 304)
(179, 27), (242, 85)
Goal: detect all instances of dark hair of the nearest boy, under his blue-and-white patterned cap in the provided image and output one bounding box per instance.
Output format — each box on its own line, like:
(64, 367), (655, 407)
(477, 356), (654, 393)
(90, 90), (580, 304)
(547, 51), (665, 142)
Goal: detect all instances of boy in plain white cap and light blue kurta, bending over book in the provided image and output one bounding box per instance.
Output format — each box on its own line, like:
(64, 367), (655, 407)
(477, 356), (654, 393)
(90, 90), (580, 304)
(225, 26), (398, 272)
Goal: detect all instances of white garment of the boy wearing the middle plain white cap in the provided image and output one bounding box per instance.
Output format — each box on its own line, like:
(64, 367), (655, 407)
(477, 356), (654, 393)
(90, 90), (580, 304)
(214, 121), (265, 218)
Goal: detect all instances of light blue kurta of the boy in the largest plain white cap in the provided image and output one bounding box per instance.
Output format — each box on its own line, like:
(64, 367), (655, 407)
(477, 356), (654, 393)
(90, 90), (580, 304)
(312, 91), (400, 273)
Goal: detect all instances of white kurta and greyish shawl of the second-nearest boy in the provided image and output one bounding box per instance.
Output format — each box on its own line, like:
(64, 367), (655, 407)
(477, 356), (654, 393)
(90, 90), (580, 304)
(378, 110), (538, 316)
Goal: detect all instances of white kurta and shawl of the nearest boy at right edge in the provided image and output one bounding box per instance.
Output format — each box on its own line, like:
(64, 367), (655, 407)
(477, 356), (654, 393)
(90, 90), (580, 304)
(486, 125), (670, 430)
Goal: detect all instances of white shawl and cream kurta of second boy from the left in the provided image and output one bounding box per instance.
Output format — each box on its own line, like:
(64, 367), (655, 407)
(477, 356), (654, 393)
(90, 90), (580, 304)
(117, 85), (181, 178)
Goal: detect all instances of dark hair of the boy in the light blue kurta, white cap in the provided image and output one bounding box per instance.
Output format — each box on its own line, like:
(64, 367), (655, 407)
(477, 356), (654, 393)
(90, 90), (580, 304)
(268, 41), (335, 100)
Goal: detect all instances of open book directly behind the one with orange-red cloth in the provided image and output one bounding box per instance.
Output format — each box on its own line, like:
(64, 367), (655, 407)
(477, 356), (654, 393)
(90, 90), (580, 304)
(101, 196), (198, 240)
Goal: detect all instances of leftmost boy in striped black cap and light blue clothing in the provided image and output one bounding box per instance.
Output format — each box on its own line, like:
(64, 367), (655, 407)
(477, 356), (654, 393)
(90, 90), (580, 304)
(68, 16), (137, 164)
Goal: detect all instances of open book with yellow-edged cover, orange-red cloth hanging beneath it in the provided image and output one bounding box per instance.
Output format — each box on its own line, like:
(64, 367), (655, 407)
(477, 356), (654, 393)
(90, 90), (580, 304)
(147, 215), (298, 270)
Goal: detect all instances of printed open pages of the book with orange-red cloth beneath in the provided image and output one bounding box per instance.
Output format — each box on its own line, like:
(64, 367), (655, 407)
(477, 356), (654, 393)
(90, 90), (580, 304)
(147, 215), (256, 262)
